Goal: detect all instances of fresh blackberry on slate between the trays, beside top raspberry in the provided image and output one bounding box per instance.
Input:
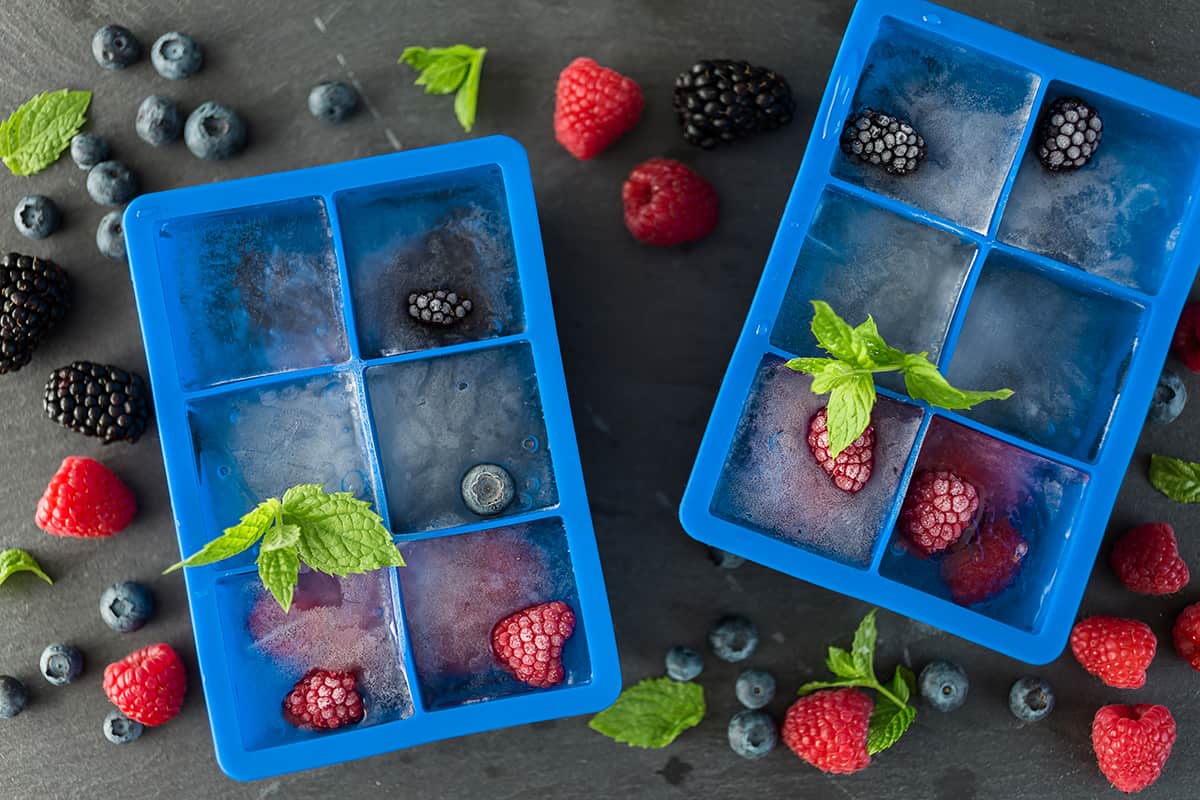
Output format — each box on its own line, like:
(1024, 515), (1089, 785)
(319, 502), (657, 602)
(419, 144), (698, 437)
(674, 59), (796, 150)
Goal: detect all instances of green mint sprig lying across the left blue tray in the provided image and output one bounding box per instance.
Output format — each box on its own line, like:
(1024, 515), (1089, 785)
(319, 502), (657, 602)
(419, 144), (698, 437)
(163, 483), (404, 613)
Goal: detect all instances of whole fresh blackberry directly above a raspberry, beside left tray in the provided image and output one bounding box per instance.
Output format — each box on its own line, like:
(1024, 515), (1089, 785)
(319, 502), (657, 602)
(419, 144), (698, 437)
(44, 361), (150, 444)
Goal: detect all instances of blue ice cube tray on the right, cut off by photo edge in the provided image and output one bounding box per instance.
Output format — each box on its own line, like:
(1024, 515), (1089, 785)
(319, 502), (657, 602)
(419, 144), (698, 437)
(680, 0), (1200, 663)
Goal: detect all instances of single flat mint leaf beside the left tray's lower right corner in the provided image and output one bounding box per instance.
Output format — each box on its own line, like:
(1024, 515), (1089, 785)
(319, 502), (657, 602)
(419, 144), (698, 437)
(588, 678), (707, 747)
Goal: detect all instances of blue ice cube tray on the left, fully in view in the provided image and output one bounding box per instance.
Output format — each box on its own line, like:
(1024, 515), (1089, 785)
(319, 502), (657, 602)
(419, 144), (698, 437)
(125, 137), (620, 780)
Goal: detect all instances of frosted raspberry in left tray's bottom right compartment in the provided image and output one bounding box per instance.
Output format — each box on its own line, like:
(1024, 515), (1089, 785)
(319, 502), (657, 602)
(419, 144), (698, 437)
(492, 600), (575, 688)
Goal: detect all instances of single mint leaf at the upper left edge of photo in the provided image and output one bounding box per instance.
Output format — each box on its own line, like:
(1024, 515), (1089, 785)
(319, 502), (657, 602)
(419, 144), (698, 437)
(0, 89), (91, 175)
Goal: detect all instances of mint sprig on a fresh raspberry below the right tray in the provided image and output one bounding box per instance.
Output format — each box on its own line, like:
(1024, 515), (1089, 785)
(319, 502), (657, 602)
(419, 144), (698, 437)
(798, 608), (917, 756)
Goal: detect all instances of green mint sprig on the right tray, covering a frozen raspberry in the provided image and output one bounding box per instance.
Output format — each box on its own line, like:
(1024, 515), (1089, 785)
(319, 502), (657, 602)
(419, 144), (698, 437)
(787, 300), (1013, 458)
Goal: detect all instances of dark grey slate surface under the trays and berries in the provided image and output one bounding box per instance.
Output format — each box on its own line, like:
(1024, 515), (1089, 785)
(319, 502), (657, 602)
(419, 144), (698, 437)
(0, 0), (1200, 800)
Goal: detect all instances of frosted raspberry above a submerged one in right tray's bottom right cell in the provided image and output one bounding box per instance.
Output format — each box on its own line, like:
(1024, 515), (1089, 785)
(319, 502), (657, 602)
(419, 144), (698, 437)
(900, 470), (979, 555)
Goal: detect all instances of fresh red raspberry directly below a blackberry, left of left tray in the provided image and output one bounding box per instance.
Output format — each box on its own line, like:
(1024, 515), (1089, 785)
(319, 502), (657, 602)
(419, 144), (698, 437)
(35, 456), (138, 537)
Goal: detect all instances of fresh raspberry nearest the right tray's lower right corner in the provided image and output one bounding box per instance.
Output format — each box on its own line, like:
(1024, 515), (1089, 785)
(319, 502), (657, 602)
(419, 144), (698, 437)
(1070, 616), (1158, 688)
